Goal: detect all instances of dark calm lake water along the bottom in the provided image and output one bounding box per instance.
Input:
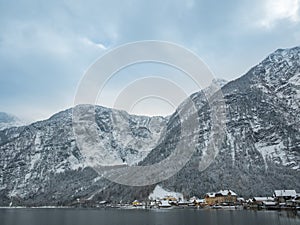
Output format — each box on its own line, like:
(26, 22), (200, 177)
(0, 208), (300, 225)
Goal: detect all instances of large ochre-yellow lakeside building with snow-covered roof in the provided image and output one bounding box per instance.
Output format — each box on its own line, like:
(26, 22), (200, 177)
(205, 190), (237, 205)
